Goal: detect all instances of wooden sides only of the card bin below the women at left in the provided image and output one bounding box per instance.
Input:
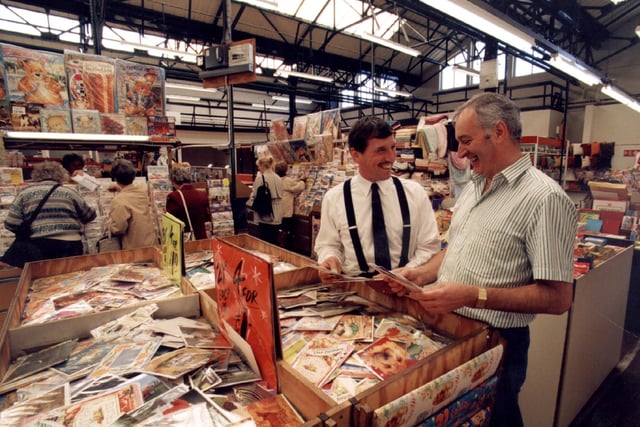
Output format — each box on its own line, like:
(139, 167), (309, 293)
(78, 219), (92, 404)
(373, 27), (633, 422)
(0, 247), (200, 378)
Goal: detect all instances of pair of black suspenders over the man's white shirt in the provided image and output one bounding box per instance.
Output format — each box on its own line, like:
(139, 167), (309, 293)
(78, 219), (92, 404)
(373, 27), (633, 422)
(343, 176), (411, 273)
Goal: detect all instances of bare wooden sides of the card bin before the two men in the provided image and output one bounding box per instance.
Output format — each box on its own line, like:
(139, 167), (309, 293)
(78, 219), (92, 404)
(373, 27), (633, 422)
(278, 282), (501, 427)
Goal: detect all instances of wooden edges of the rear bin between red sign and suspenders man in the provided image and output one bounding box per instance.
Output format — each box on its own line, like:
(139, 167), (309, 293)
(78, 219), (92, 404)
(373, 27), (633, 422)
(219, 234), (320, 289)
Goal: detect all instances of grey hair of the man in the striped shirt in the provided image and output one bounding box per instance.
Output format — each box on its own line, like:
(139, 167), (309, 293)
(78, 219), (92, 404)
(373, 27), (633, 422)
(453, 92), (522, 144)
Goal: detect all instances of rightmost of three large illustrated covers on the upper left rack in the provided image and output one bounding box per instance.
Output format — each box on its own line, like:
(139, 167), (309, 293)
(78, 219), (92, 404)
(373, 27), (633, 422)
(116, 59), (165, 117)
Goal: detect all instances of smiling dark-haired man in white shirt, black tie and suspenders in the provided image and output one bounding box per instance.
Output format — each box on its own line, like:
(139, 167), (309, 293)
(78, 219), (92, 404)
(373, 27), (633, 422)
(315, 117), (441, 282)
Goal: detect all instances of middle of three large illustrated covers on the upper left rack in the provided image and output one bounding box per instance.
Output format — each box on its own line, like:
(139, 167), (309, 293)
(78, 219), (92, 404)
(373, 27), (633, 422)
(64, 50), (116, 113)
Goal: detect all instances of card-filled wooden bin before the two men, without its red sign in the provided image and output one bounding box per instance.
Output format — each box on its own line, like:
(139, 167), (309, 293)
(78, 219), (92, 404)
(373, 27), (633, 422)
(278, 281), (502, 426)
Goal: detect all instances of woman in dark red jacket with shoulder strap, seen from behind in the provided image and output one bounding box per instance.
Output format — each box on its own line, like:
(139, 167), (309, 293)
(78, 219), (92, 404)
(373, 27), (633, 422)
(166, 163), (211, 240)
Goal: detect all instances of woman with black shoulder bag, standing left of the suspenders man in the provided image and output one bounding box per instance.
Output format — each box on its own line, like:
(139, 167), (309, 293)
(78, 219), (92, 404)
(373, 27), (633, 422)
(247, 155), (284, 245)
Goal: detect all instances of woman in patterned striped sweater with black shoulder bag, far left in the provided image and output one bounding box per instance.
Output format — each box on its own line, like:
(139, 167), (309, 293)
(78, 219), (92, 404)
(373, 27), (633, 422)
(4, 161), (96, 261)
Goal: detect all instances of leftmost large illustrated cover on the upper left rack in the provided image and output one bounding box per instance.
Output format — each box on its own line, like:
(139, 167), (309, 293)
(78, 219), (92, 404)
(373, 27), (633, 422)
(2, 44), (69, 109)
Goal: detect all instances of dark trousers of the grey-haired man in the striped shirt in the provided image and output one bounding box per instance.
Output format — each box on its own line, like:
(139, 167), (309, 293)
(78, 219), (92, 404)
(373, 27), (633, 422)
(491, 326), (530, 427)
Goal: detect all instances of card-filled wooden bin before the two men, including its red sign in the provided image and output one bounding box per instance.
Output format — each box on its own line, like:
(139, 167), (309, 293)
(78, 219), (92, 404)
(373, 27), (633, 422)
(213, 239), (502, 426)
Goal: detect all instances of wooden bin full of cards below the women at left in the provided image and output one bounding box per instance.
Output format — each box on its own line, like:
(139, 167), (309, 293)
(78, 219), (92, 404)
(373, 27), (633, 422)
(0, 247), (200, 377)
